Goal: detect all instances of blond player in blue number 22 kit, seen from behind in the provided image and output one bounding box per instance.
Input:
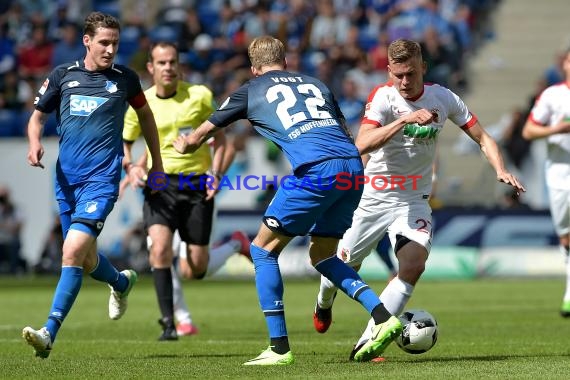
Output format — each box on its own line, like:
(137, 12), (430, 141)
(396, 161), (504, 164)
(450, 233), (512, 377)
(174, 36), (402, 365)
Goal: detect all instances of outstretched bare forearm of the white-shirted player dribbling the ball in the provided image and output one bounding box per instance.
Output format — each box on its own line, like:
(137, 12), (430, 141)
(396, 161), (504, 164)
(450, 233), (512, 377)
(463, 121), (526, 191)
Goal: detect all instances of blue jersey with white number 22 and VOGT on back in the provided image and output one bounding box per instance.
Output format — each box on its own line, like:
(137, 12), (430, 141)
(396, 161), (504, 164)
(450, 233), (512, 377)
(209, 70), (360, 170)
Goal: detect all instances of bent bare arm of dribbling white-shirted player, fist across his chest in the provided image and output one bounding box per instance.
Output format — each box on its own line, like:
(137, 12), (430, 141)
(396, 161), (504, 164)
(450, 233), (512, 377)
(356, 108), (434, 155)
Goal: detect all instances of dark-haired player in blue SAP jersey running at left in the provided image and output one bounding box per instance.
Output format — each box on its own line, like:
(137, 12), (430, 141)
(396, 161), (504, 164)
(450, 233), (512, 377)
(22, 12), (163, 358)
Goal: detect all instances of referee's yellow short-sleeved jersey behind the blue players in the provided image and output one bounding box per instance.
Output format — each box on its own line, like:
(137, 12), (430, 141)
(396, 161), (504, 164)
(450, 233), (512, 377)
(123, 81), (216, 175)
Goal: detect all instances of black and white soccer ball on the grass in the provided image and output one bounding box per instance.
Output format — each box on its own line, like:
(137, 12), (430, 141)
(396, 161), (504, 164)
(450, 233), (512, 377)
(396, 309), (437, 354)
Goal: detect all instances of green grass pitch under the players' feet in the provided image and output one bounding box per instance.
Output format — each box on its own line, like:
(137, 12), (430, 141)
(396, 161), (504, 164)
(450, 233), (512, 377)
(0, 275), (570, 380)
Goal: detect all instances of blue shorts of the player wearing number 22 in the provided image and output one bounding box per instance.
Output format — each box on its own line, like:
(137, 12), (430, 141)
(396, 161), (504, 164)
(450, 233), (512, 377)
(263, 157), (364, 239)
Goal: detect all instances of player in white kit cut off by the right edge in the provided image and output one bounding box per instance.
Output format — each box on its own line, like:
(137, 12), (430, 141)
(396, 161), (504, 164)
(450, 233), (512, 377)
(522, 50), (570, 318)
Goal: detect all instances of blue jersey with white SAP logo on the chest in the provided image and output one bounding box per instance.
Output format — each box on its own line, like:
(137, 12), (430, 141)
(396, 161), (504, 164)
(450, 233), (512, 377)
(36, 62), (142, 185)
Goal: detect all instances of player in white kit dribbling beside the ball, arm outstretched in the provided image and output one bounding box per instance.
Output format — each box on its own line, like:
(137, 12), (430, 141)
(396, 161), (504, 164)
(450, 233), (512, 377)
(313, 40), (525, 359)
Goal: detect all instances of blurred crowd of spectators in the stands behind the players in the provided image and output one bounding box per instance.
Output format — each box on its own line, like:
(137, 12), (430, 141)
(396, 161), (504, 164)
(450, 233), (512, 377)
(0, 0), (499, 136)
